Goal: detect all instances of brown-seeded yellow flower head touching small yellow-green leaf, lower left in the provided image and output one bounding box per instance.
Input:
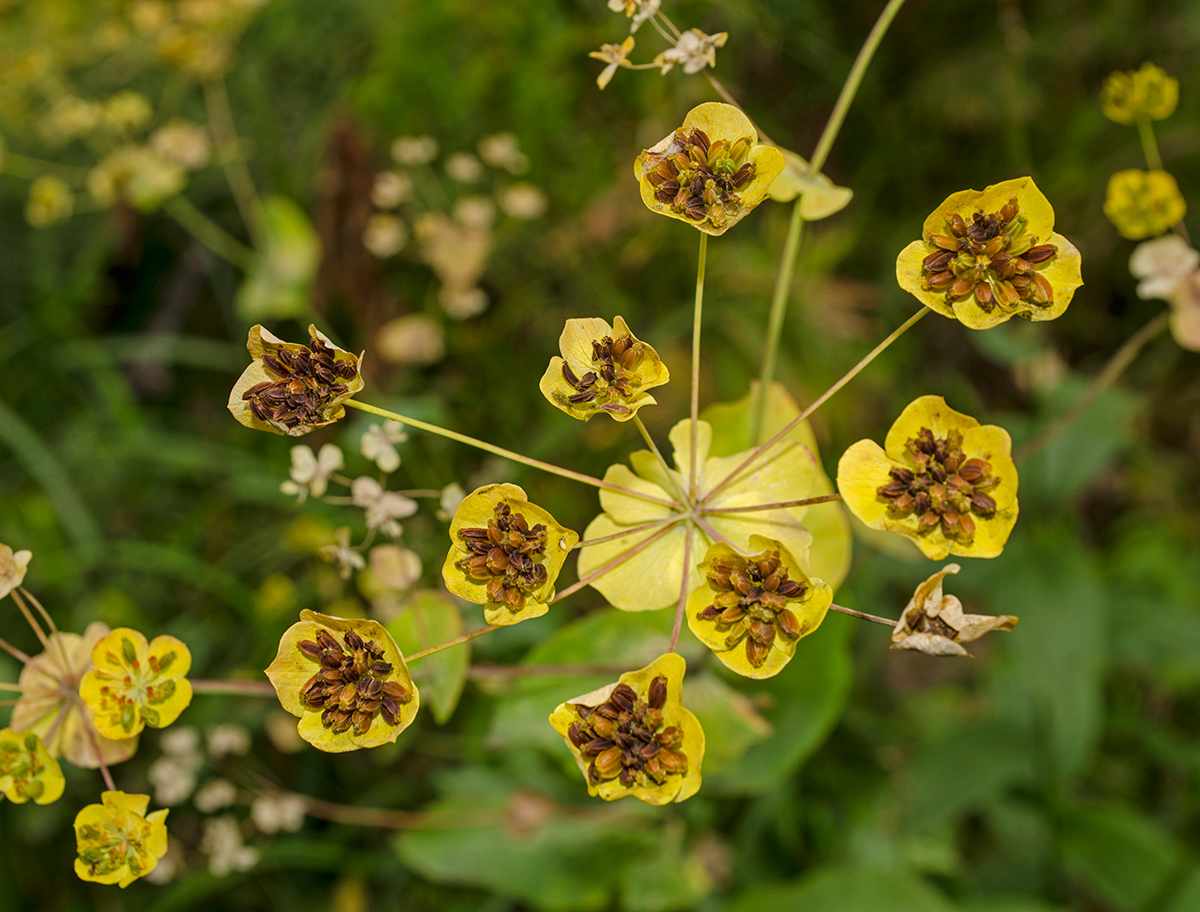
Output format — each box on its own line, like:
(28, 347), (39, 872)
(266, 611), (421, 754)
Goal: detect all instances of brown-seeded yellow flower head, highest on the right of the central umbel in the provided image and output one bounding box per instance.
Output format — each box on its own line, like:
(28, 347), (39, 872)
(896, 178), (1084, 329)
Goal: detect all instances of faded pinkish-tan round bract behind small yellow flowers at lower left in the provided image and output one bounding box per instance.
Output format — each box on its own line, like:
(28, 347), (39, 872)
(11, 622), (138, 769)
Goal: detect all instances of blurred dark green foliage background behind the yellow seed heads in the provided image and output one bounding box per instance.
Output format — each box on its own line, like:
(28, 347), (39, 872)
(0, 0), (1200, 912)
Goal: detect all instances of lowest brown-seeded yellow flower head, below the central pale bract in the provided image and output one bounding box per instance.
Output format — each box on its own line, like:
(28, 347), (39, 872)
(550, 653), (704, 804)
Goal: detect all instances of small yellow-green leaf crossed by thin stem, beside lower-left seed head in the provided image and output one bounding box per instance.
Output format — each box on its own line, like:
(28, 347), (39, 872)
(388, 589), (470, 725)
